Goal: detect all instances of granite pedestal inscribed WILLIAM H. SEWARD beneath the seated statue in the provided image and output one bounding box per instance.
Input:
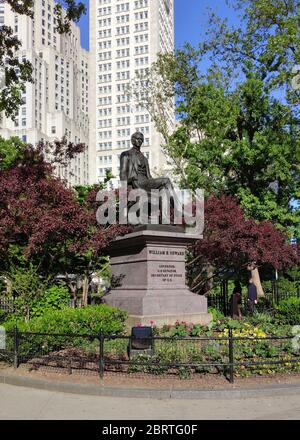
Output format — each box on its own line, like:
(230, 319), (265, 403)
(104, 226), (211, 327)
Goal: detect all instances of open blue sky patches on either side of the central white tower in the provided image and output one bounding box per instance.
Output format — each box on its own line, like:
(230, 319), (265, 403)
(80, 0), (236, 48)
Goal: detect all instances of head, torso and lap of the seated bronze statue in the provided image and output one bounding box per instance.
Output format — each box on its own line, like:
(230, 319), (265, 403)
(120, 133), (173, 192)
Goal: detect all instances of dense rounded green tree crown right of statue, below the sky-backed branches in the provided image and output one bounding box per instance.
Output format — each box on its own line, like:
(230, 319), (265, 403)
(171, 74), (299, 236)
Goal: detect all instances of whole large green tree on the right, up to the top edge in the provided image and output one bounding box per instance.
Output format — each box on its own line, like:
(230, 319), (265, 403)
(139, 0), (300, 241)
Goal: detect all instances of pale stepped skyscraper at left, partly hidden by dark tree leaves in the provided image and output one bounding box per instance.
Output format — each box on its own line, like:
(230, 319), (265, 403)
(0, 0), (89, 185)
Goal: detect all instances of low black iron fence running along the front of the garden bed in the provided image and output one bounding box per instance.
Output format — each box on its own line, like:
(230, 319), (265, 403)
(0, 328), (300, 383)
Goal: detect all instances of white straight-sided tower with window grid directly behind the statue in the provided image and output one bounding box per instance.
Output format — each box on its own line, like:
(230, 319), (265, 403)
(89, 0), (175, 183)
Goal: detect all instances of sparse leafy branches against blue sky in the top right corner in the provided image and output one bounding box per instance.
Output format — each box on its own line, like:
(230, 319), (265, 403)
(200, 0), (300, 96)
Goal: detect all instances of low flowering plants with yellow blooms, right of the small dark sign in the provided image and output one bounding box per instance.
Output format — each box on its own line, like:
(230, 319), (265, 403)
(123, 314), (300, 378)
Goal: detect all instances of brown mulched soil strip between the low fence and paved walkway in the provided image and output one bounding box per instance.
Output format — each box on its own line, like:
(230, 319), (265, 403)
(0, 349), (300, 390)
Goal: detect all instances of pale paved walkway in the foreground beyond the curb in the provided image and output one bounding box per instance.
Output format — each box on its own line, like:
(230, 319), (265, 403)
(0, 384), (300, 421)
